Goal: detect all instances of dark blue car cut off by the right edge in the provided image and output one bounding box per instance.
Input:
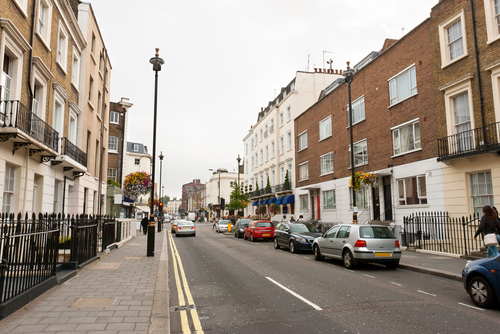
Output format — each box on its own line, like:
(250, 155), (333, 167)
(462, 256), (500, 308)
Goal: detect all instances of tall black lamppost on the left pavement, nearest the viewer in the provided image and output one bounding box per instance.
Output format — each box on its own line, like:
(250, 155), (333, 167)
(147, 48), (165, 256)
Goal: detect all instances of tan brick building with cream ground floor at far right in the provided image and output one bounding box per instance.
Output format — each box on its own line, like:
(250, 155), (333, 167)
(430, 0), (500, 216)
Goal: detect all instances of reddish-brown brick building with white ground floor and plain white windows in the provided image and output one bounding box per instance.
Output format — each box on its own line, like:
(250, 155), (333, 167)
(295, 19), (443, 224)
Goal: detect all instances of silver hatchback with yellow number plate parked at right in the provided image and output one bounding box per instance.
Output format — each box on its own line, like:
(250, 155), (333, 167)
(313, 224), (401, 269)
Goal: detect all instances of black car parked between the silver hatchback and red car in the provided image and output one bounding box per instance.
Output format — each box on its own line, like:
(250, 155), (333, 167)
(274, 222), (321, 253)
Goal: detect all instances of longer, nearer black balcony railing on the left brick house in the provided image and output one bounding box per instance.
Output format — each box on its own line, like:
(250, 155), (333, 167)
(0, 100), (59, 151)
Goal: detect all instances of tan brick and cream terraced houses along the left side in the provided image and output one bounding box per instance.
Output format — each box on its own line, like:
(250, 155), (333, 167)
(0, 0), (111, 214)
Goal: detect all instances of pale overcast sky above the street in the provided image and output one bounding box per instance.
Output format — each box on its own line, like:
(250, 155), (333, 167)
(89, 0), (438, 198)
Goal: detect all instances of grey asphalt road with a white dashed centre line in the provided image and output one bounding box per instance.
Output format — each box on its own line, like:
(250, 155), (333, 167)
(169, 224), (500, 334)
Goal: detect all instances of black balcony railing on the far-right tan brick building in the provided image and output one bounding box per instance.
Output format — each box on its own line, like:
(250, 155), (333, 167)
(438, 122), (500, 161)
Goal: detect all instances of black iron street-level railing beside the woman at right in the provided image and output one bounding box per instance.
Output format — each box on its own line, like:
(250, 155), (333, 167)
(401, 212), (483, 255)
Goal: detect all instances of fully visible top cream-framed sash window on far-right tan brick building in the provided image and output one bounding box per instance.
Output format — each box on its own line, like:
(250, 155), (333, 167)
(439, 10), (467, 67)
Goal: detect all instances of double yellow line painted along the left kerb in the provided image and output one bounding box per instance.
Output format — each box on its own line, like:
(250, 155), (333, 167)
(168, 233), (204, 334)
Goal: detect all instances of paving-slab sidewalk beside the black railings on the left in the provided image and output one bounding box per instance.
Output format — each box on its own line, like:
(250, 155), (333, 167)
(0, 233), (168, 334)
